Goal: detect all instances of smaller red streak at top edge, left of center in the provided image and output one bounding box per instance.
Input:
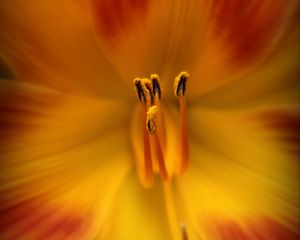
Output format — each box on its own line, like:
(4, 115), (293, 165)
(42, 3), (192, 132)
(93, 0), (149, 39)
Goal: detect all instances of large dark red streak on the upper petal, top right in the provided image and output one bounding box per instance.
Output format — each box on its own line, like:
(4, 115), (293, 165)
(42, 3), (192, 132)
(212, 0), (288, 63)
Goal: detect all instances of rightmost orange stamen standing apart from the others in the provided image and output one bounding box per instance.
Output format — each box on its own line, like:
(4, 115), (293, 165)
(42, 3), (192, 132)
(174, 72), (189, 172)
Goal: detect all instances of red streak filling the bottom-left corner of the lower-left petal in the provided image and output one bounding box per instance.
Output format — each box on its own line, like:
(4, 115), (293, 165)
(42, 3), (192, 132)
(0, 200), (91, 240)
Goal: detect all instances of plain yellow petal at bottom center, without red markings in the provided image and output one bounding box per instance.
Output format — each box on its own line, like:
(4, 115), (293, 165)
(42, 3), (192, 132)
(98, 172), (173, 240)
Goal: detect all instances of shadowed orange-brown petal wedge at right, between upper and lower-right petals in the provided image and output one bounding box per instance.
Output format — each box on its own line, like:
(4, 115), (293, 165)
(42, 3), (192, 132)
(188, 22), (300, 104)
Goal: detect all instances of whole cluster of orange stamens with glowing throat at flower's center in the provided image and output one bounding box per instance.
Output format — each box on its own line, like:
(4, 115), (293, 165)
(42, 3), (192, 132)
(133, 72), (189, 187)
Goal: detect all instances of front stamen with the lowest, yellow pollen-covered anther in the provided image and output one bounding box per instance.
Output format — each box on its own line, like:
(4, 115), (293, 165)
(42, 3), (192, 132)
(146, 105), (168, 180)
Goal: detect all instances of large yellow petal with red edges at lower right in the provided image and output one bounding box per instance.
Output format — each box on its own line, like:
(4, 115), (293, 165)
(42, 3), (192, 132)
(178, 106), (300, 239)
